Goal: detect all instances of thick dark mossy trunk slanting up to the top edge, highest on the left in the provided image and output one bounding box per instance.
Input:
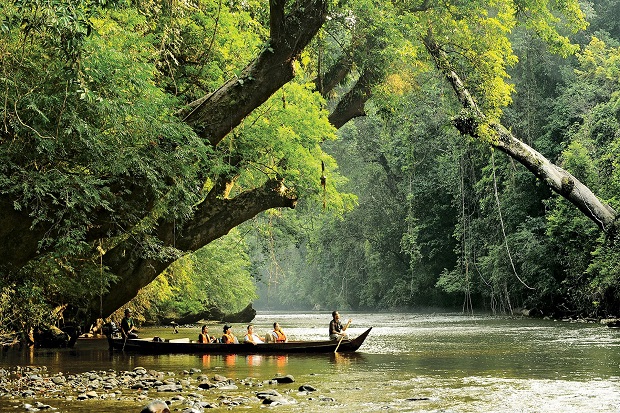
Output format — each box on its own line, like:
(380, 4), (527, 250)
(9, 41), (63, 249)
(182, 0), (327, 146)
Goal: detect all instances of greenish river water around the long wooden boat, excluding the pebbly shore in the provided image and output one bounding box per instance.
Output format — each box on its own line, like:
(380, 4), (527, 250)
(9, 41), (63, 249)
(0, 312), (620, 413)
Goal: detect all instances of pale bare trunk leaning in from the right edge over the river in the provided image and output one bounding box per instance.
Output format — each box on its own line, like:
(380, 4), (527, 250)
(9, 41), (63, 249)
(424, 32), (617, 232)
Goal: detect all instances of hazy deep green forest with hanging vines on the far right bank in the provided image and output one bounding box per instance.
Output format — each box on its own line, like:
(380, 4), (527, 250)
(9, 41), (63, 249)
(252, 1), (620, 317)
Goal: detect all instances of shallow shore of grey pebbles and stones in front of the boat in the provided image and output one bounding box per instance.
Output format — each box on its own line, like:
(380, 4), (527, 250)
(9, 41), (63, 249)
(0, 366), (336, 413)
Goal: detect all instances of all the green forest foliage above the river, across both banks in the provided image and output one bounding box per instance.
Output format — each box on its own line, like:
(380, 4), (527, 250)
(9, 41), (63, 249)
(0, 0), (620, 336)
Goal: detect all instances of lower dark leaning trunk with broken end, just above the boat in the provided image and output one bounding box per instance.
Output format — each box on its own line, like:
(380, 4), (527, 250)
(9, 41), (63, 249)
(93, 179), (297, 317)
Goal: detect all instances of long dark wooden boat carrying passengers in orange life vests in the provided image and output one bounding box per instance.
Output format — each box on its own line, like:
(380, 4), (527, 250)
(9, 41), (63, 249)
(108, 327), (372, 354)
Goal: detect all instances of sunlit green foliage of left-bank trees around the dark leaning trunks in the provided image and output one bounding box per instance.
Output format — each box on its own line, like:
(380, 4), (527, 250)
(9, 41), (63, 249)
(0, 0), (350, 329)
